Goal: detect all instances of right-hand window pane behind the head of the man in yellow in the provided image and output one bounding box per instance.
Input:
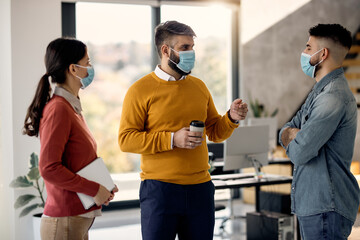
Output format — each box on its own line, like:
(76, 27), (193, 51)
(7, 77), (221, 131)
(161, 5), (231, 114)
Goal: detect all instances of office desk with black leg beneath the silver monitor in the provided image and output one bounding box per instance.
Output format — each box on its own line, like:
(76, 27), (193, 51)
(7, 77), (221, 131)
(211, 173), (292, 212)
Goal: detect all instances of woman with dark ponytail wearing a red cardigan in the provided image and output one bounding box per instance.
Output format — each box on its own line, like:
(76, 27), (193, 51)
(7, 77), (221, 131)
(23, 38), (117, 239)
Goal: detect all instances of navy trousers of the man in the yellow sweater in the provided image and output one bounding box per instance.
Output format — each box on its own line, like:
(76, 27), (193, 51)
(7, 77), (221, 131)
(140, 180), (215, 240)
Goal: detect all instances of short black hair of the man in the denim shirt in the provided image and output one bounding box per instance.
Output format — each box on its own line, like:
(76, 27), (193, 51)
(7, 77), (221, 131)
(309, 24), (352, 49)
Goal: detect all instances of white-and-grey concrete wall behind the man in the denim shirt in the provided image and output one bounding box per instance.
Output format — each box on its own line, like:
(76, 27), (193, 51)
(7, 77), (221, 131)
(241, 0), (360, 126)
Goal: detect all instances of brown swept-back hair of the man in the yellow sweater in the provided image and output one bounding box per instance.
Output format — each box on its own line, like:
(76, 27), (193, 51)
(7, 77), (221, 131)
(155, 21), (196, 57)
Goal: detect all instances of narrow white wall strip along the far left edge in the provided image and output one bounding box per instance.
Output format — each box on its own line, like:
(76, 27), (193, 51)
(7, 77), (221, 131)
(0, 0), (15, 239)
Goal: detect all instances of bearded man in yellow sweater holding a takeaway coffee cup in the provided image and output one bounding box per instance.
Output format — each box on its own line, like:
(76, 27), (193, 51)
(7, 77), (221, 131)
(119, 21), (248, 240)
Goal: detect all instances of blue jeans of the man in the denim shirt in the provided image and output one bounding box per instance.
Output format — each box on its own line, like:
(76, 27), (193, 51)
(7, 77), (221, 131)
(298, 212), (354, 240)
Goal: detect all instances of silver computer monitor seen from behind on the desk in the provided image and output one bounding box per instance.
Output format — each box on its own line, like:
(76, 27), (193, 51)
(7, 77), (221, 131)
(223, 125), (269, 172)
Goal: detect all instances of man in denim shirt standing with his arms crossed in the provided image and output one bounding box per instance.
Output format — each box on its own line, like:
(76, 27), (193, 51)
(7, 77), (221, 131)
(279, 24), (359, 240)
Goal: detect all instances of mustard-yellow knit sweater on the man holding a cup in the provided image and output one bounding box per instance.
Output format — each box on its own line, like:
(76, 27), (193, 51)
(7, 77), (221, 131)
(119, 72), (238, 184)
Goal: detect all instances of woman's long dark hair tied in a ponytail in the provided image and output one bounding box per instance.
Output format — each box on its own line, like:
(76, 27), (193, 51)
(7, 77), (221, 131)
(23, 38), (86, 137)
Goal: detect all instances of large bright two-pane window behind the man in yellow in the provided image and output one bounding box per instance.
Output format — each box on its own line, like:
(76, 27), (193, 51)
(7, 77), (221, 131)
(76, 2), (235, 201)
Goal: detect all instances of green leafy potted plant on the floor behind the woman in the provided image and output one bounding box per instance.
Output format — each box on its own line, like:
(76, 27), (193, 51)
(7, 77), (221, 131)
(10, 152), (45, 239)
